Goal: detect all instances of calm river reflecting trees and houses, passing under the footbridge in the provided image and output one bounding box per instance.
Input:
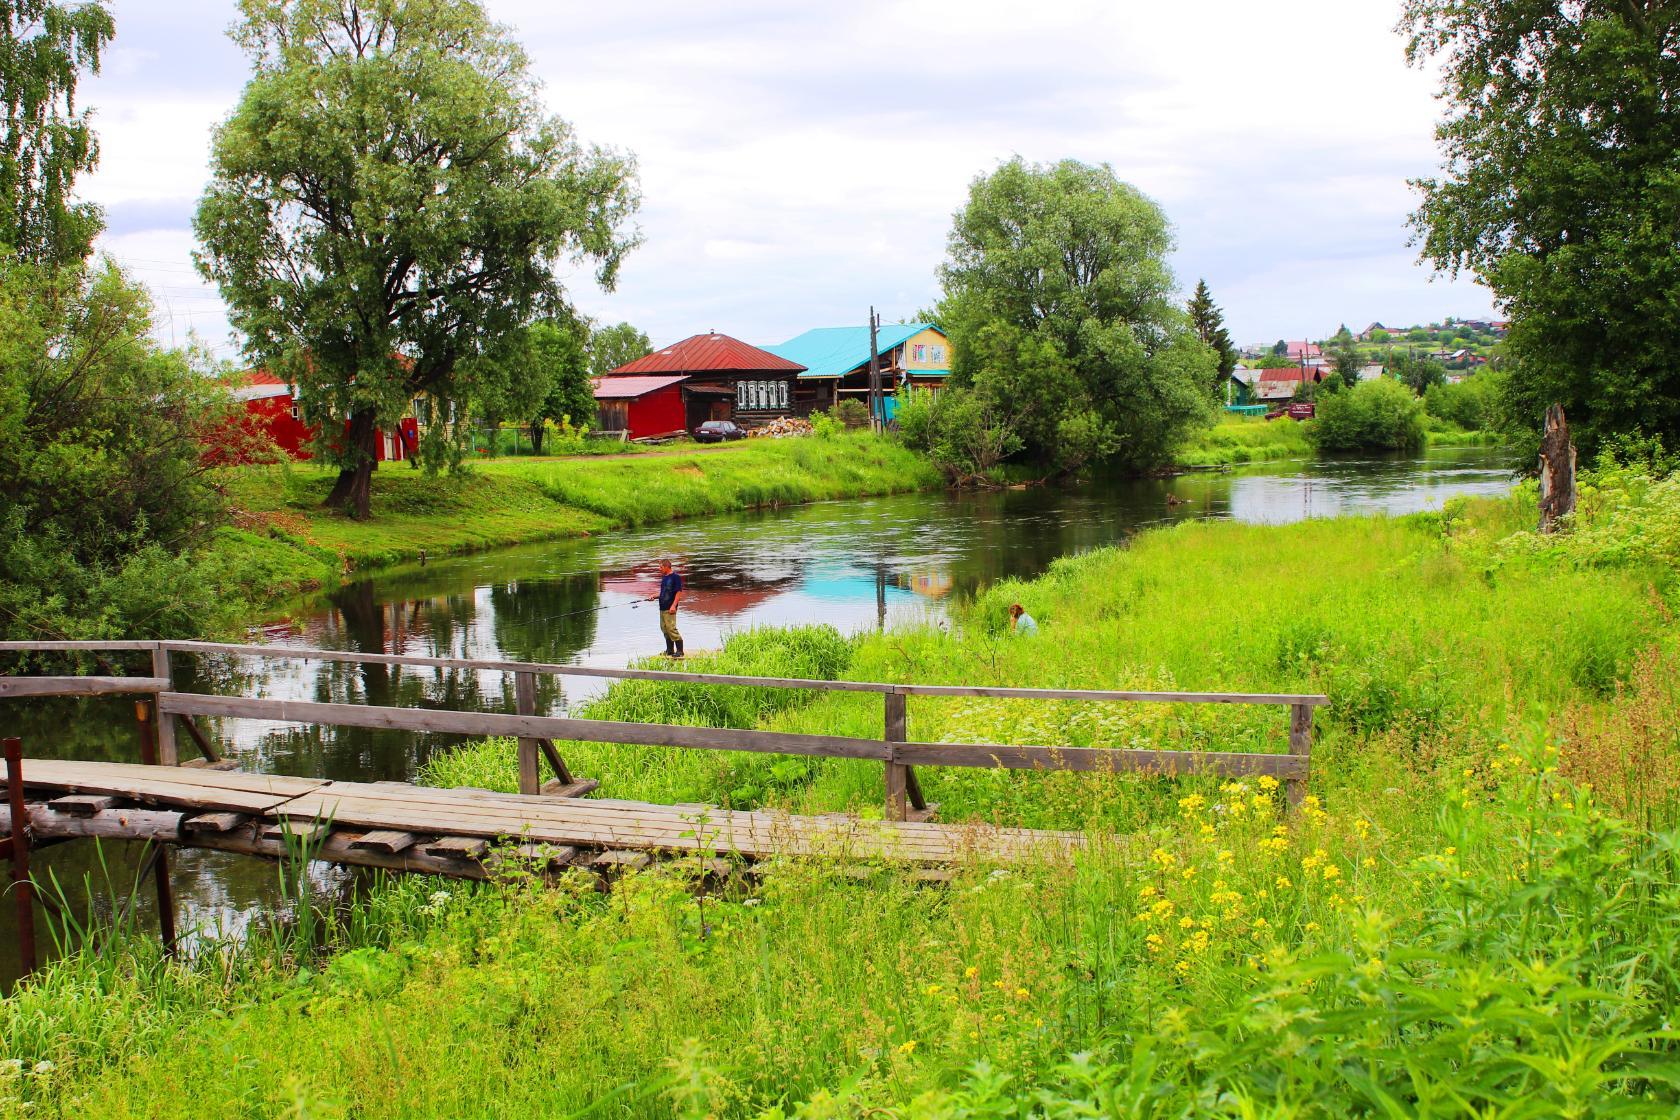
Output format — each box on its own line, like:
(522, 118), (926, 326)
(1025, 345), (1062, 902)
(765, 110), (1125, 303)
(0, 448), (1510, 987)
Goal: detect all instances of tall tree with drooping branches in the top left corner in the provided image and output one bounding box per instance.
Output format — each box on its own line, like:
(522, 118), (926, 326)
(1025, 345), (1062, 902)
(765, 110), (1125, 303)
(0, 0), (114, 265)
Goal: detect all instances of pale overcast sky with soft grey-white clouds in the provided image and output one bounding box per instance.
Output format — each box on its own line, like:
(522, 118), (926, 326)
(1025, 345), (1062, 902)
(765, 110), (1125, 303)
(82, 0), (1492, 358)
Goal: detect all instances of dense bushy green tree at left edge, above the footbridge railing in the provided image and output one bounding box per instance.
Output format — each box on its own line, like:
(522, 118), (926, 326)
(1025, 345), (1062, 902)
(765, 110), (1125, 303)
(0, 257), (239, 638)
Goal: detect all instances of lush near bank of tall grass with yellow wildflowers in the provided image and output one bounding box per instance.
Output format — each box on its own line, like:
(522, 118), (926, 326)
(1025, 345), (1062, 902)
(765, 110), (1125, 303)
(0, 475), (1680, 1120)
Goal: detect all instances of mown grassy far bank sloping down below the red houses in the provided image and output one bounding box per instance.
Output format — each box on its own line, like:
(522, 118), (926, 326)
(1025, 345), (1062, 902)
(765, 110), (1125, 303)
(210, 435), (939, 601)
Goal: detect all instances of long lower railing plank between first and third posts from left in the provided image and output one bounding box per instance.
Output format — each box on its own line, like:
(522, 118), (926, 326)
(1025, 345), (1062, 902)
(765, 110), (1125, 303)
(160, 692), (887, 761)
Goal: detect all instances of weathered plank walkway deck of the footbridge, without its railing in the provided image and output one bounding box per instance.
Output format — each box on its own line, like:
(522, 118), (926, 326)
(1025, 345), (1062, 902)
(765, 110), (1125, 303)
(6, 759), (1084, 873)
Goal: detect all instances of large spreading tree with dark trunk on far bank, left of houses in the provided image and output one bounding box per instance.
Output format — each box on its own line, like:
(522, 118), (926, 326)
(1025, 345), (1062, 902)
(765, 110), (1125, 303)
(193, 0), (638, 517)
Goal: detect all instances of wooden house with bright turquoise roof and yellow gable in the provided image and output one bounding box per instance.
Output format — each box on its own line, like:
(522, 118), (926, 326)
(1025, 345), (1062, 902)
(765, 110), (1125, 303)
(766, 322), (951, 420)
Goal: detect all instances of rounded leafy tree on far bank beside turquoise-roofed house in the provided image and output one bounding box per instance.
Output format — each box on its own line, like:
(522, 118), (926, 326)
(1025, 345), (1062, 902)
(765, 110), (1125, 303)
(937, 158), (1216, 470)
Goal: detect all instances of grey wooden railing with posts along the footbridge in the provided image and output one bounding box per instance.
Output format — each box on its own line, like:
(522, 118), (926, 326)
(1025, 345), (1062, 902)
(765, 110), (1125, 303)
(0, 641), (1329, 821)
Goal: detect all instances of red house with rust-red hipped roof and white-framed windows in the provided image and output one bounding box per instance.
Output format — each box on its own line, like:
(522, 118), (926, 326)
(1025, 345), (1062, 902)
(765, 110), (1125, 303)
(595, 332), (810, 440)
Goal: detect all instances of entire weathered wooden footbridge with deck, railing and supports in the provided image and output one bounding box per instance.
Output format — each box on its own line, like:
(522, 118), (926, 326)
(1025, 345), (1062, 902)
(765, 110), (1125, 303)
(0, 641), (1327, 973)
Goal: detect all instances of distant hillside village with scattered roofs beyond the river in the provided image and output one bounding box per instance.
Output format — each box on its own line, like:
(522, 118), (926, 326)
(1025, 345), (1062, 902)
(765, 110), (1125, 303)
(1225, 319), (1507, 413)
